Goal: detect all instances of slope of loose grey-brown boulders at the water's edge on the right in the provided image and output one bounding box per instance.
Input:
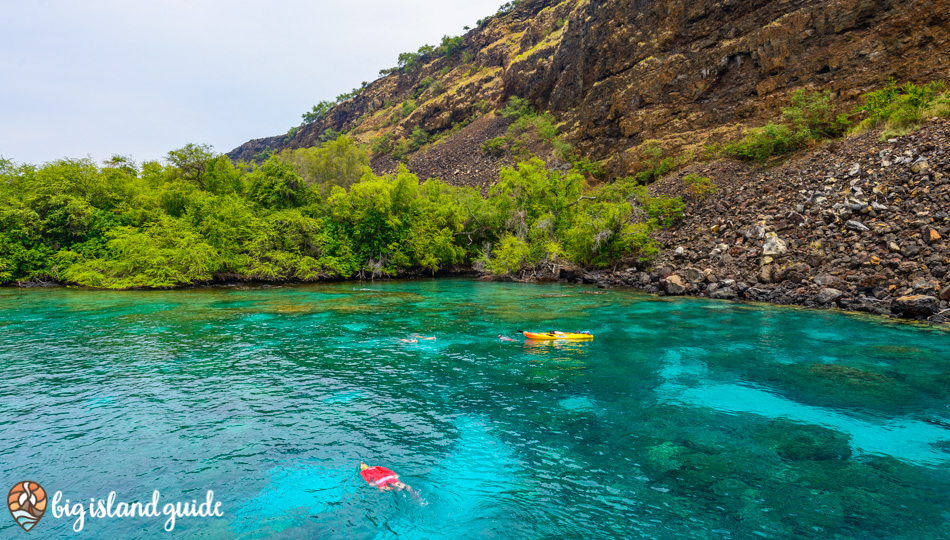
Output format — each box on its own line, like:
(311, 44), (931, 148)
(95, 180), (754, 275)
(588, 118), (950, 323)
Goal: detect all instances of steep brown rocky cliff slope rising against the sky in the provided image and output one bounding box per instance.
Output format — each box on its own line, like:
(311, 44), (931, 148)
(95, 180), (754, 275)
(229, 0), (950, 188)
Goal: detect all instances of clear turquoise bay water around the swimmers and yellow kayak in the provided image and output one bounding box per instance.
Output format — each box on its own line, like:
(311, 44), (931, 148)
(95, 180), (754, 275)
(0, 280), (950, 539)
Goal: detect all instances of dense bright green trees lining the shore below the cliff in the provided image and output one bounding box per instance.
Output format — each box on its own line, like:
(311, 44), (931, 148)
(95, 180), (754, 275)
(0, 141), (682, 288)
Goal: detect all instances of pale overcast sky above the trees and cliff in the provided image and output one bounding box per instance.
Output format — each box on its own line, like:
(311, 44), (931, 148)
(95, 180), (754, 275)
(0, 0), (503, 164)
